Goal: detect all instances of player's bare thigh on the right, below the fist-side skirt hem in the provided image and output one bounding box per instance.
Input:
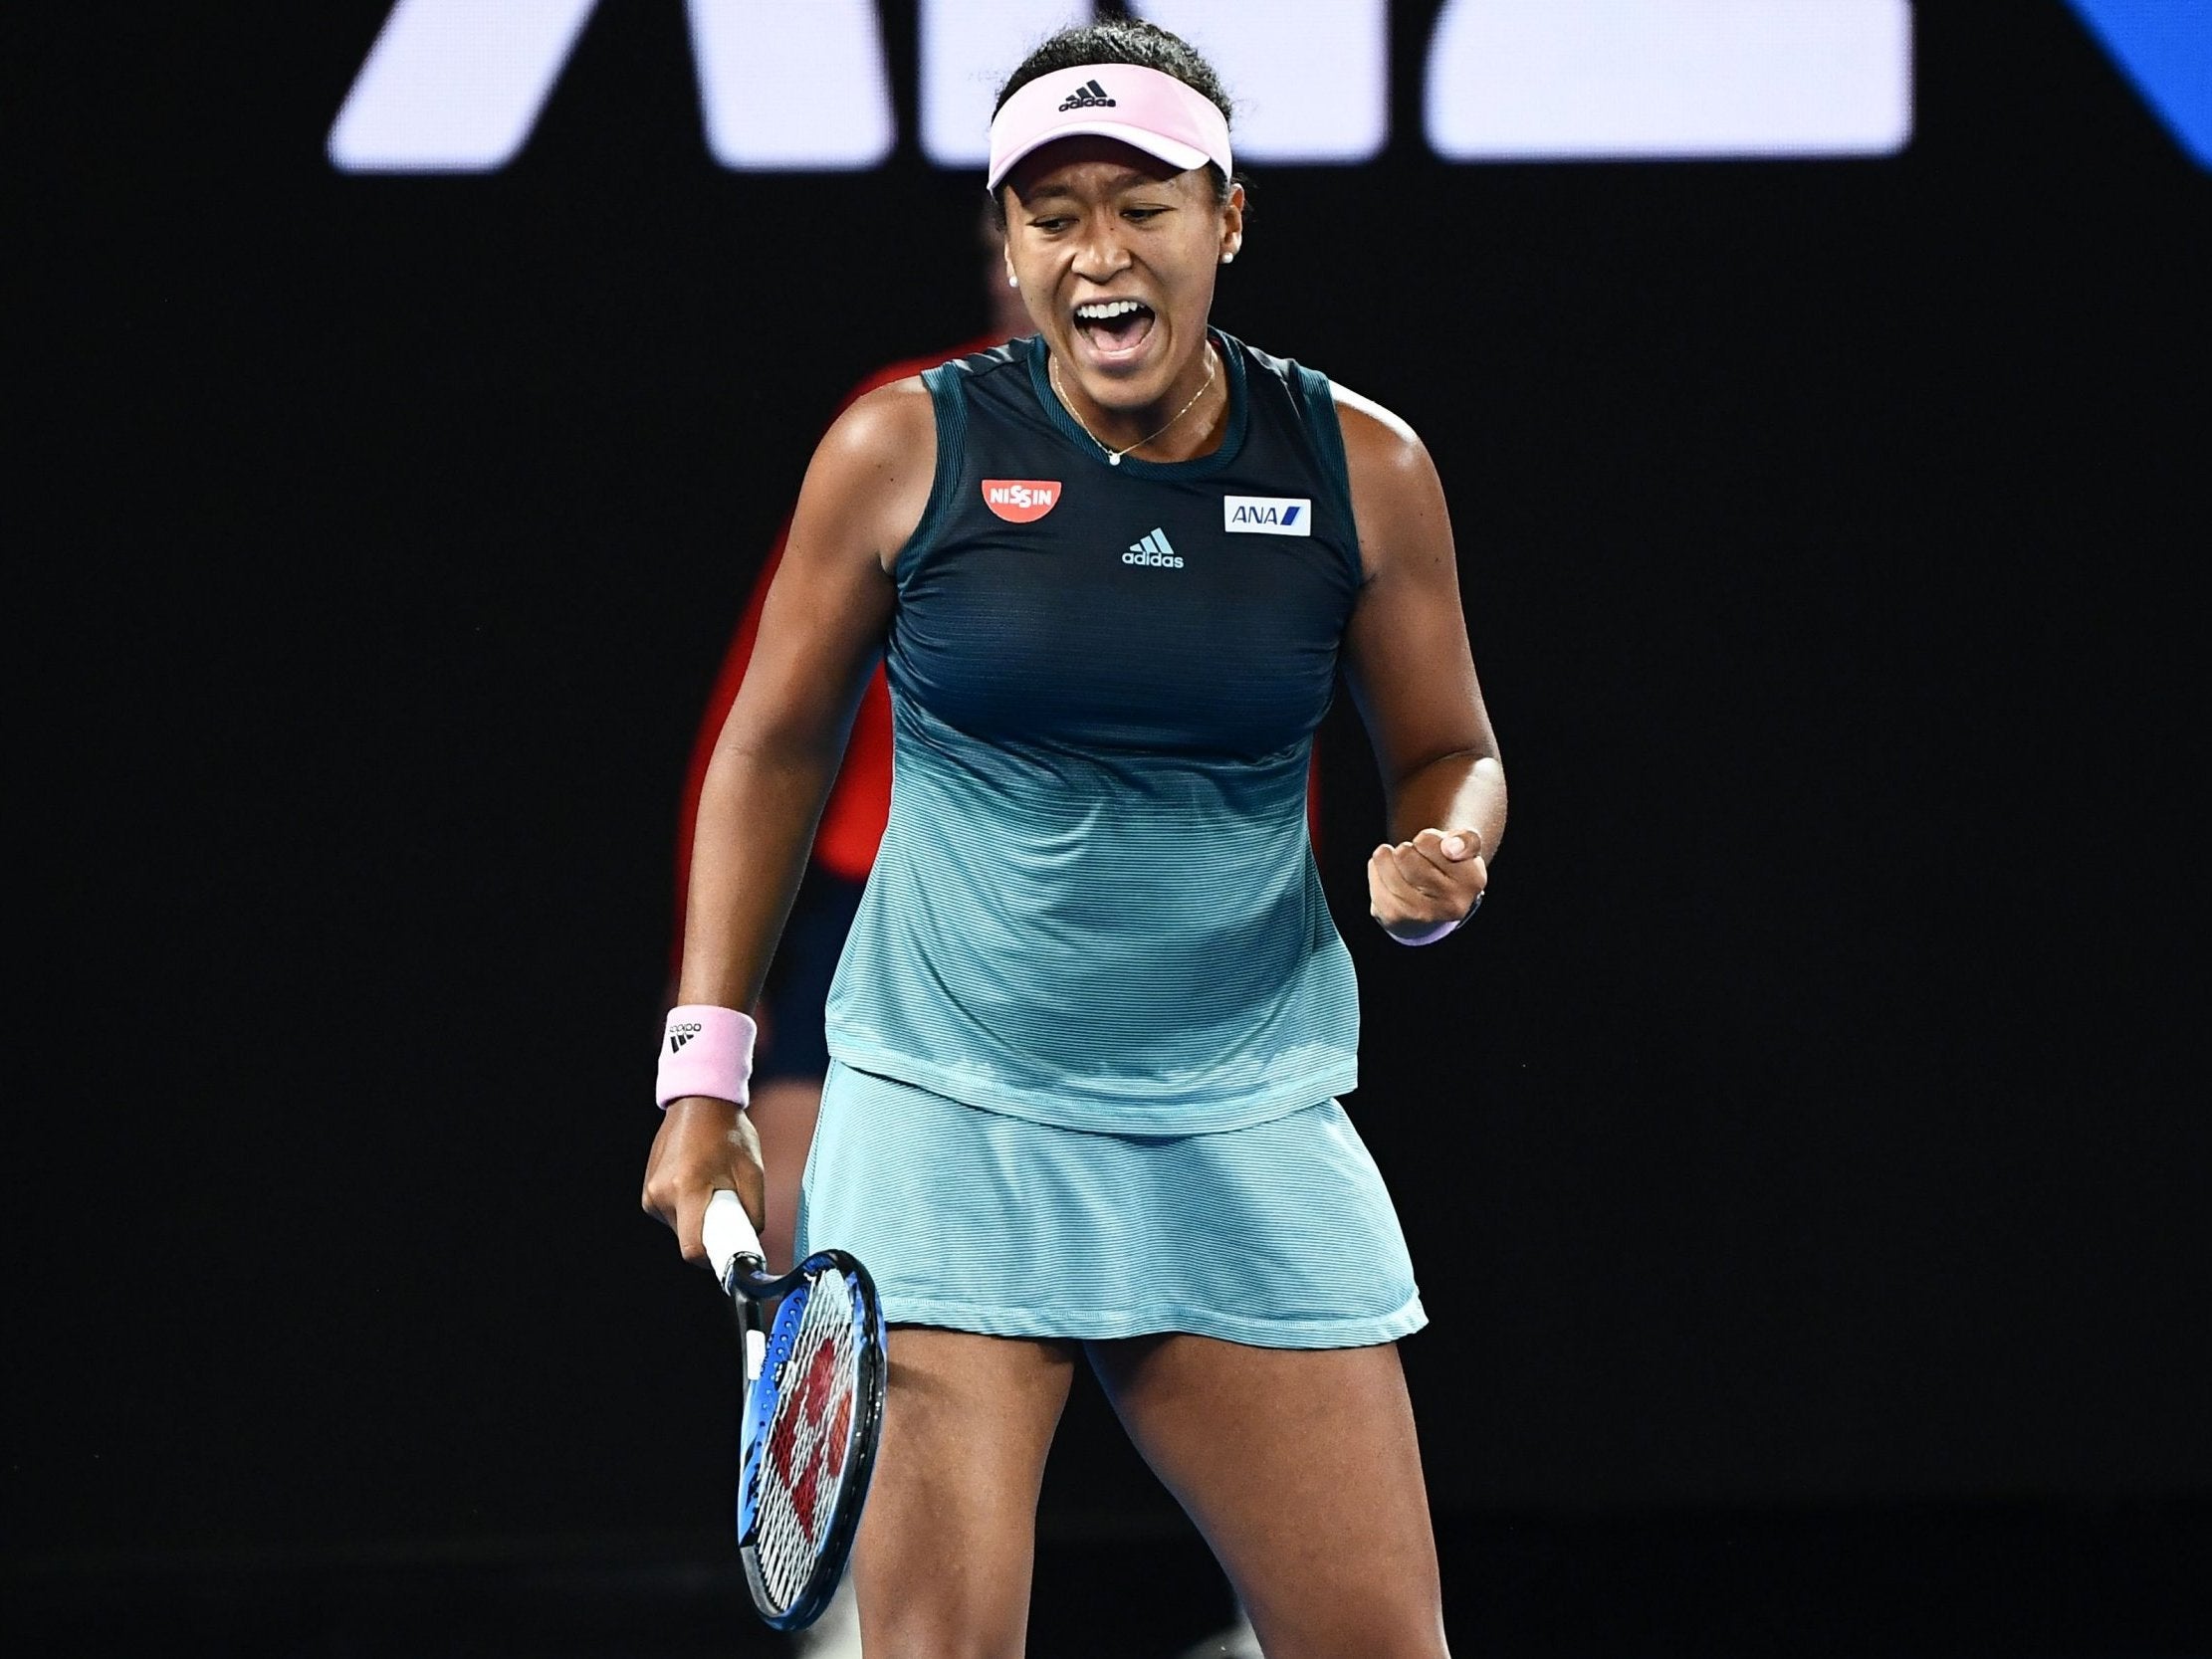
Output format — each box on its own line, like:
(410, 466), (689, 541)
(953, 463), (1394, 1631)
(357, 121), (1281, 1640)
(1090, 1334), (1444, 1659)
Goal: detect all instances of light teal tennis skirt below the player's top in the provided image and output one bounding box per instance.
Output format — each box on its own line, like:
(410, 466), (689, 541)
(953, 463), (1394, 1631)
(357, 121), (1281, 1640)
(798, 1062), (1427, 1348)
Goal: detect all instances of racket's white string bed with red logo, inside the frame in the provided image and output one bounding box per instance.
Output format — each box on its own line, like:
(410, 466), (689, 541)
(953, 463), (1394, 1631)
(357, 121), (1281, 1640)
(757, 1272), (858, 1606)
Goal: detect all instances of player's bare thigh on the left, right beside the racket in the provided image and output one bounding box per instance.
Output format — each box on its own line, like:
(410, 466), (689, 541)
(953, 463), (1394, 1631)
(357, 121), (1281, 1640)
(851, 1325), (1077, 1659)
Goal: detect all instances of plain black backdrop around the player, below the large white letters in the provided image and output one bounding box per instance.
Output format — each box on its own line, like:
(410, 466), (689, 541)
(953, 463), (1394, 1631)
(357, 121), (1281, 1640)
(17, 0), (2212, 1652)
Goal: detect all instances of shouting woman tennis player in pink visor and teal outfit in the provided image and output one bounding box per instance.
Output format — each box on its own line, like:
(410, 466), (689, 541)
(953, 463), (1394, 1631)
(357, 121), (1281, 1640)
(644, 22), (1506, 1659)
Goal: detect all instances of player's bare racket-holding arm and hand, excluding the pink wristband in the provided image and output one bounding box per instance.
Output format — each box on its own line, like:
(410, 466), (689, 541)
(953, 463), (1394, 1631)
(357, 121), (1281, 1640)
(644, 380), (936, 1261)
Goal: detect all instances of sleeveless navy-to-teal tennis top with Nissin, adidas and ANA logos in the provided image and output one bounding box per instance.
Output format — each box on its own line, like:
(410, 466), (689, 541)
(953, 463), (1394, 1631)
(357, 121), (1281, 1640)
(827, 331), (1361, 1135)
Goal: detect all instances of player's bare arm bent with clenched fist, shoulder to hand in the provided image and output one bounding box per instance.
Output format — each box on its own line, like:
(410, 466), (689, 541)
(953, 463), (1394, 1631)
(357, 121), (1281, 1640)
(1336, 387), (1506, 940)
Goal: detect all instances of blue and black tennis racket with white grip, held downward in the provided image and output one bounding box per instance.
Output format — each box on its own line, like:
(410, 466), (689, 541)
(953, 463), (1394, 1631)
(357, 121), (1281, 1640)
(704, 1192), (885, 1630)
